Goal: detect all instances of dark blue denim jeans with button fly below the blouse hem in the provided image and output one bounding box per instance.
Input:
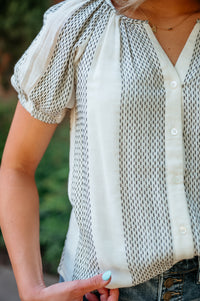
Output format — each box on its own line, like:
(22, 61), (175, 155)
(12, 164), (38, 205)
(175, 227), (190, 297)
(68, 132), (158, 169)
(58, 256), (200, 301)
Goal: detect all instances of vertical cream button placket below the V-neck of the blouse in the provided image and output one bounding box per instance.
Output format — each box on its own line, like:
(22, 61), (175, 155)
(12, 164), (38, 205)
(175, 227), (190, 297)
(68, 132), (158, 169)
(165, 74), (194, 260)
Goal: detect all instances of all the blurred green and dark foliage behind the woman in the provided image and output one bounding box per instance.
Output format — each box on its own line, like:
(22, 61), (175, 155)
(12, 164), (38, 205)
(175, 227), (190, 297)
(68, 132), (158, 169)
(0, 0), (71, 273)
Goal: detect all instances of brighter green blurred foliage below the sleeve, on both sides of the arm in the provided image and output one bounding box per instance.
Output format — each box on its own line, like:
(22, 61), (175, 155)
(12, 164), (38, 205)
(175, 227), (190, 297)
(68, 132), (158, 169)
(0, 99), (71, 273)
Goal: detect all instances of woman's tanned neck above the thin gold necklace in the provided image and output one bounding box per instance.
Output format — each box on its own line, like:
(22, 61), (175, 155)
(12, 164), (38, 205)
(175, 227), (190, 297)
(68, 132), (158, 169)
(141, 0), (200, 18)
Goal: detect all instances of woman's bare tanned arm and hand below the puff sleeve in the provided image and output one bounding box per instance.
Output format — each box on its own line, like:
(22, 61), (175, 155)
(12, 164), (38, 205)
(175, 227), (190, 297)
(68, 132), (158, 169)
(0, 104), (118, 301)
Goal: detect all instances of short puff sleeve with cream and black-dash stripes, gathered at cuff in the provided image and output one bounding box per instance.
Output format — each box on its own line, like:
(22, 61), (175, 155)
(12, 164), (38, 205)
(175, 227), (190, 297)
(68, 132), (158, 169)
(11, 0), (83, 123)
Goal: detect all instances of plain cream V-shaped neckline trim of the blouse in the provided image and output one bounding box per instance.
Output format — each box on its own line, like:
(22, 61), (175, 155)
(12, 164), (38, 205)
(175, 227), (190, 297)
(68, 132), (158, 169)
(144, 19), (200, 83)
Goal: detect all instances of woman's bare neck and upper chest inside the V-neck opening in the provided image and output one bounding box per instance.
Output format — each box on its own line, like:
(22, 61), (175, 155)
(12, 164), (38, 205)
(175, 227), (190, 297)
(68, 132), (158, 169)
(118, 0), (200, 66)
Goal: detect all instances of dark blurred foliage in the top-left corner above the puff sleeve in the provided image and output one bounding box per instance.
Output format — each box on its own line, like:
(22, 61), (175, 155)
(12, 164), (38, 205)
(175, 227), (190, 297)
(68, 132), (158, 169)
(0, 0), (53, 88)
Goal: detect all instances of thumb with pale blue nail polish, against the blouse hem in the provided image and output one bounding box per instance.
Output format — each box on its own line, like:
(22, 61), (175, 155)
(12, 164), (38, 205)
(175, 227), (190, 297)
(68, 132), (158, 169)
(71, 271), (111, 297)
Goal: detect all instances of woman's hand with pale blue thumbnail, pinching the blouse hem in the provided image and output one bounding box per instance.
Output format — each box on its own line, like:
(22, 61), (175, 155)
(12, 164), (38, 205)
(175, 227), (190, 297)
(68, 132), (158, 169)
(22, 275), (119, 301)
